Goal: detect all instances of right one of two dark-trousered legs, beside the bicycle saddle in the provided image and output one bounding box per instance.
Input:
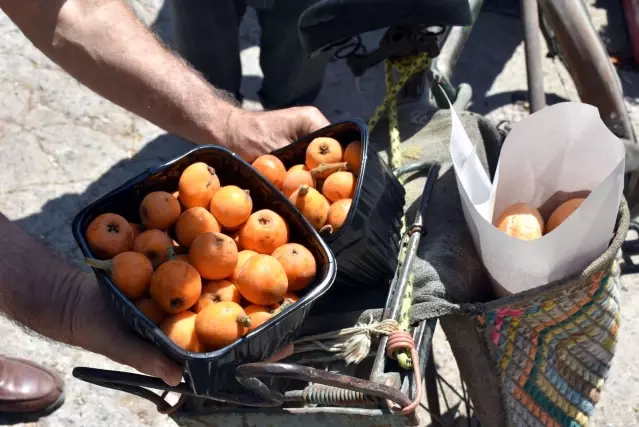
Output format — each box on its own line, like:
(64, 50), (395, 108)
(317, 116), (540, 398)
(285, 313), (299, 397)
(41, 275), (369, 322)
(258, 0), (330, 109)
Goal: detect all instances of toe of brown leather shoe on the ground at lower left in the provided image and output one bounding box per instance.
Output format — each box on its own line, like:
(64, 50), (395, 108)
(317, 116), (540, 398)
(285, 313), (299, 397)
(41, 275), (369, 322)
(0, 356), (64, 424)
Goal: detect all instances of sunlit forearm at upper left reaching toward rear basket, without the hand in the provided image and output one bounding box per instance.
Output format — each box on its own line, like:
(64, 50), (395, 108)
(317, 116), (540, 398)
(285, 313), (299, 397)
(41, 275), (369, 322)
(0, 0), (236, 148)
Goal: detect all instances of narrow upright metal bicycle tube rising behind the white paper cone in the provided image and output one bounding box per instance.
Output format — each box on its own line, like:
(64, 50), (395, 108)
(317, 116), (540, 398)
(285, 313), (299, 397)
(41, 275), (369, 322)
(521, 0), (546, 113)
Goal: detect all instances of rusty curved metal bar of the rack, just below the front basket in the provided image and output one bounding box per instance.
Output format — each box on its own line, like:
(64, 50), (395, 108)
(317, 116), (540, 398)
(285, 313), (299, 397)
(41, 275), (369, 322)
(235, 362), (411, 408)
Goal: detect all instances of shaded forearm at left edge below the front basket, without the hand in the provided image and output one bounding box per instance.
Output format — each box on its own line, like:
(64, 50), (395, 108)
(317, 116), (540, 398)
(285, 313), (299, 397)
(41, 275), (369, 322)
(0, 213), (83, 342)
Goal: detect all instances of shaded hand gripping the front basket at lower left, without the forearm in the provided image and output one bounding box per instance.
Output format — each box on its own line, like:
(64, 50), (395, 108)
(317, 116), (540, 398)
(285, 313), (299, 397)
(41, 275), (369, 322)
(62, 271), (182, 386)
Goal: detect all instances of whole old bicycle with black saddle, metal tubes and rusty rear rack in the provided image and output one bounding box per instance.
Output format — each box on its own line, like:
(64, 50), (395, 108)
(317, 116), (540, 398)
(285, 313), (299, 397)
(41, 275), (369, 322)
(74, 0), (636, 426)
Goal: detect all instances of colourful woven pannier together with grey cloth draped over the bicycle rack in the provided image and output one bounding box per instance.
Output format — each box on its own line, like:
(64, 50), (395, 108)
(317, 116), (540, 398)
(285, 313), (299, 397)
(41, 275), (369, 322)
(308, 111), (629, 427)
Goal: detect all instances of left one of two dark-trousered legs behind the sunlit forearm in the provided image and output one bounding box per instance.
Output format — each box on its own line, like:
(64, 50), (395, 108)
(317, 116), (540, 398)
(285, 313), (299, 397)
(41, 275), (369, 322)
(167, 0), (246, 100)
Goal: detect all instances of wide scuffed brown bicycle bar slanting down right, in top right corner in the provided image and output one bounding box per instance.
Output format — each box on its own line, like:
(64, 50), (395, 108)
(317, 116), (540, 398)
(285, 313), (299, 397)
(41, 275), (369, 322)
(539, 0), (639, 205)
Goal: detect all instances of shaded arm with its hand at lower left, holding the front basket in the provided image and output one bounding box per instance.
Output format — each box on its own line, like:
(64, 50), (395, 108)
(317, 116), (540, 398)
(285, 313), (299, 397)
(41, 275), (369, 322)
(0, 213), (182, 385)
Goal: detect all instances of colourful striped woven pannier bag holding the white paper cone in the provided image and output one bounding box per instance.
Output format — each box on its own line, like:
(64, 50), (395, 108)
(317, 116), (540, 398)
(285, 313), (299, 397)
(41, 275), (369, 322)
(442, 200), (629, 427)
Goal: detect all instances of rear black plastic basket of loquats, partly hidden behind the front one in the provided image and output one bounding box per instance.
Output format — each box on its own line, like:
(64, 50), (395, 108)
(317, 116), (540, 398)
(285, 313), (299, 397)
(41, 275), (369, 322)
(272, 120), (406, 292)
